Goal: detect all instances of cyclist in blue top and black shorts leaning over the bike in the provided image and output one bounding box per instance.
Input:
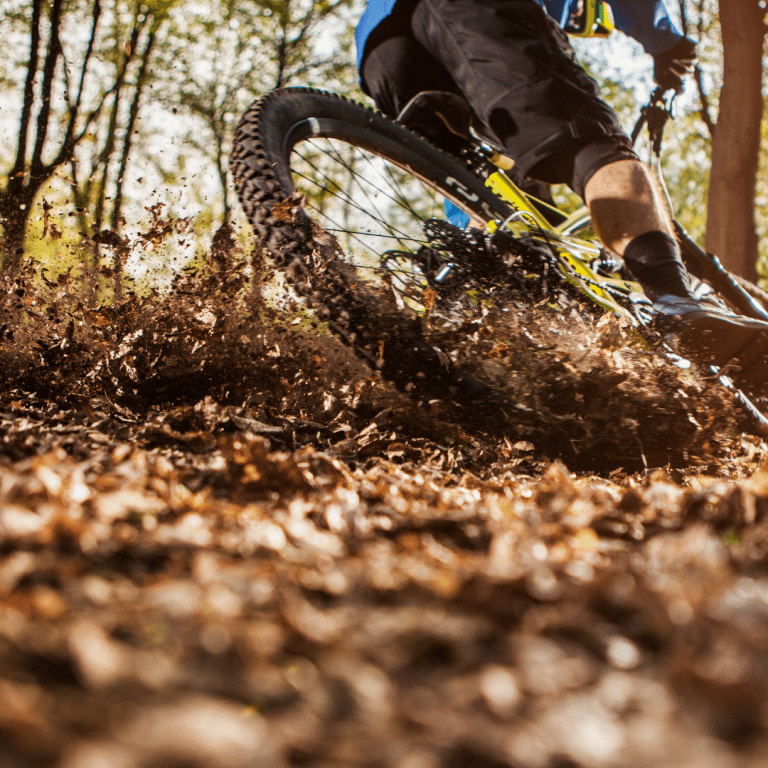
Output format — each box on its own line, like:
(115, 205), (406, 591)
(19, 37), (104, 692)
(356, 0), (768, 378)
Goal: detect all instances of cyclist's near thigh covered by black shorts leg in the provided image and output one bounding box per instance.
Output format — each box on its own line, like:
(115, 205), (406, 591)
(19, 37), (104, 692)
(407, 0), (636, 178)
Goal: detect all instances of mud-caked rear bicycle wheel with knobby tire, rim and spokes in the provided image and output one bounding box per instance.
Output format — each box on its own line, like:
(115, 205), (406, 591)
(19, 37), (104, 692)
(231, 88), (511, 396)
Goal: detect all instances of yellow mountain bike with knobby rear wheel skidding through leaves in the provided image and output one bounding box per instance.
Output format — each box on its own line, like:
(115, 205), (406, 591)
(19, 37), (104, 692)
(231, 88), (768, 424)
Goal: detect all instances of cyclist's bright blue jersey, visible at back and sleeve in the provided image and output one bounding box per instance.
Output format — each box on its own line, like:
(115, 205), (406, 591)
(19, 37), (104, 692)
(355, 0), (683, 65)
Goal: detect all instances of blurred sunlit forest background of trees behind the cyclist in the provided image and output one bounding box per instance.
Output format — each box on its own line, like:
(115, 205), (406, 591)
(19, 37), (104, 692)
(0, 0), (768, 294)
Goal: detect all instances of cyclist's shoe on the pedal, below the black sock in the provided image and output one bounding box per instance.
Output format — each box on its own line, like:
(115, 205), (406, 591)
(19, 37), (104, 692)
(653, 294), (768, 388)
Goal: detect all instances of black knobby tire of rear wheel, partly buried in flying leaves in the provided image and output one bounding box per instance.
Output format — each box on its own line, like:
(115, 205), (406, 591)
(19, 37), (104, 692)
(231, 88), (511, 402)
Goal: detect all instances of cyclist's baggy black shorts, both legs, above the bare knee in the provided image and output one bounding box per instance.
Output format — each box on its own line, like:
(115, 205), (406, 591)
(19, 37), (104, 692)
(361, 0), (637, 197)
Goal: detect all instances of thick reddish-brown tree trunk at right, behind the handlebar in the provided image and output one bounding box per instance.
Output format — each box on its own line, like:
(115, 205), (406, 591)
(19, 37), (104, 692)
(706, 0), (766, 281)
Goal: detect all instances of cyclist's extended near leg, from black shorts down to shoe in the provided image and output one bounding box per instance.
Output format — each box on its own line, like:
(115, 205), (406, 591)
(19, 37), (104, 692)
(356, 0), (768, 379)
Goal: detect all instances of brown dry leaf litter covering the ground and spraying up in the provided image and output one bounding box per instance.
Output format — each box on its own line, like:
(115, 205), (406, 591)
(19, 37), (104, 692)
(0, 236), (768, 768)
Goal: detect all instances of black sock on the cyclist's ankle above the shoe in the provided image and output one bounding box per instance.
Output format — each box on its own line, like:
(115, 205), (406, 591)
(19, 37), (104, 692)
(624, 230), (691, 301)
